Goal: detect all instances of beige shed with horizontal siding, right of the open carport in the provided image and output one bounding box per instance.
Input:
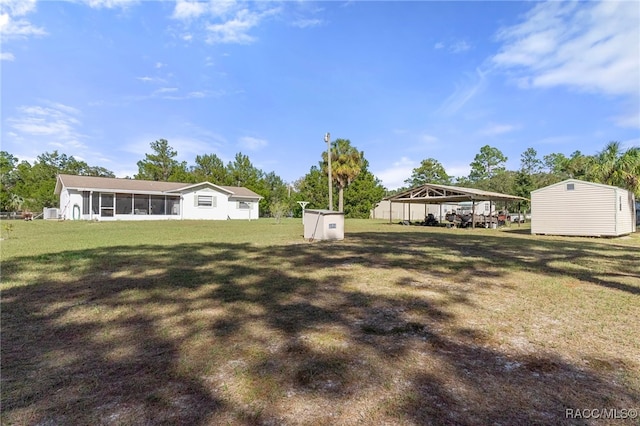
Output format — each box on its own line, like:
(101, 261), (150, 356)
(531, 179), (636, 237)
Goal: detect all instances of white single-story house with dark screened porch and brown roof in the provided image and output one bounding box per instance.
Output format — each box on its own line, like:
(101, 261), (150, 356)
(55, 174), (262, 220)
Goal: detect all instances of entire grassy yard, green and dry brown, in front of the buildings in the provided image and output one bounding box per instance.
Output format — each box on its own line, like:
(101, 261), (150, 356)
(0, 219), (640, 425)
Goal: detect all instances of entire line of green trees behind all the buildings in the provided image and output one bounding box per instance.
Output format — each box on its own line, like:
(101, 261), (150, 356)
(0, 139), (640, 218)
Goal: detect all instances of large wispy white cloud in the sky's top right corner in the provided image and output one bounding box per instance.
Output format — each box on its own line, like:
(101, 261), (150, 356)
(492, 1), (640, 97)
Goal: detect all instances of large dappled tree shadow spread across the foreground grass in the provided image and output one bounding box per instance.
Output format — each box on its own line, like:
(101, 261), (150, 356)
(1, 232), (640, 425)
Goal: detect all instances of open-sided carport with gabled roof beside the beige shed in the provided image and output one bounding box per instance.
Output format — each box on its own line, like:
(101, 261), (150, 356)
(386, 183), (528, 228)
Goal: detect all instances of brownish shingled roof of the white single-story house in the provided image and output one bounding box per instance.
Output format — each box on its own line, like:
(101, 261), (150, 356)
(54, 174), (262, 198)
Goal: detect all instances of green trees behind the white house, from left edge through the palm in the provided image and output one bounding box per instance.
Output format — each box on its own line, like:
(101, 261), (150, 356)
(0, 139), (385, 218)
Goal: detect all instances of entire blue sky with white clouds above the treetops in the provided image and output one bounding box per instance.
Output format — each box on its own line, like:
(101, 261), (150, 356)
(0, 0), (640, 189)
